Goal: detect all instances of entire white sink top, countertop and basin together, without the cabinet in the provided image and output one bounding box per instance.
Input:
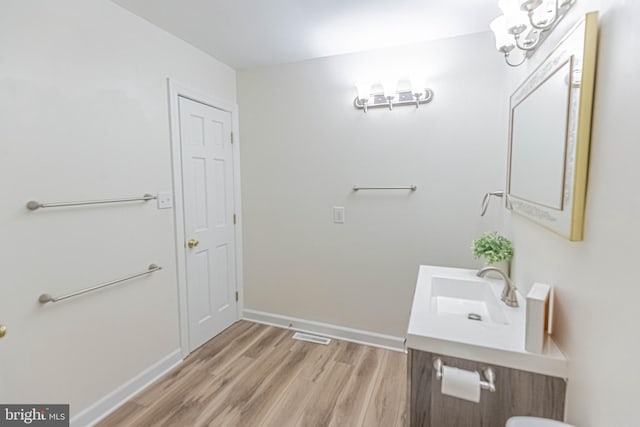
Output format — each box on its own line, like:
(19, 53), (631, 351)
(406, 265), (568, 378)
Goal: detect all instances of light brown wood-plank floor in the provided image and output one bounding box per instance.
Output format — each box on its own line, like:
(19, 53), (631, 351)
(97, 321), (407, 427)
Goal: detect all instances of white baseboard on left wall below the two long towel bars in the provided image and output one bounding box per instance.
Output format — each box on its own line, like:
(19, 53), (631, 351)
(70, 349), (182, 427)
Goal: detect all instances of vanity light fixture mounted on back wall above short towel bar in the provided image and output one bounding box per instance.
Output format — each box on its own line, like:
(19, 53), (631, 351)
(353, 80), (433, 113)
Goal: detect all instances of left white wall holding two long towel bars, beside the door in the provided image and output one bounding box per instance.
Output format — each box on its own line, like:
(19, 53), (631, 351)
(0, 0), (235, 422)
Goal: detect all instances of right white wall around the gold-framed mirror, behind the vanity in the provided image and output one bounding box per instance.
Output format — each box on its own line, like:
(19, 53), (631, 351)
(507, 0), (640, 427)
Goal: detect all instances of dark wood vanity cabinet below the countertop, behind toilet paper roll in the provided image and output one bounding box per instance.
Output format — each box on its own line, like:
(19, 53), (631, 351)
(407, 349), (566, 427)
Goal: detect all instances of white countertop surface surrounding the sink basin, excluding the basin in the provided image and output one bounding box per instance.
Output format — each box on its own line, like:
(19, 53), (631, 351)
(407, 265), (568, 378)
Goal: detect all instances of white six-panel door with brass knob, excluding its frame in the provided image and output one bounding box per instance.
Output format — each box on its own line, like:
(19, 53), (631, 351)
(179, 97), (237, 351)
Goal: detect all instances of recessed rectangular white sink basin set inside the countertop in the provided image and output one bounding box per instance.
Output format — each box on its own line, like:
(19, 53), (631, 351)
(430, 275), (509, 325)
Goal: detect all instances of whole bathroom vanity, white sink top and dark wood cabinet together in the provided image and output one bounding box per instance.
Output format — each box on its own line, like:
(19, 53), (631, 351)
(407, 266), (567, 427)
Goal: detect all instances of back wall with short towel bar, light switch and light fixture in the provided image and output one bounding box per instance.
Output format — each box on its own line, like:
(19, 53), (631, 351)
(238, 34), (508, 336)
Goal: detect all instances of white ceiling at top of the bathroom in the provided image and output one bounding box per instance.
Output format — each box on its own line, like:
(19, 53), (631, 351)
(112, 0), (500, 69)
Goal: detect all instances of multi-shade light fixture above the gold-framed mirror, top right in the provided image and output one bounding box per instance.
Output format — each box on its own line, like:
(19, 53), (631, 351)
(489, 0), (576, 67)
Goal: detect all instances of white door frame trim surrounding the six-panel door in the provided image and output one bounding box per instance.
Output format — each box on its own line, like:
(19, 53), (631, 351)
(167, 78), (244, 359)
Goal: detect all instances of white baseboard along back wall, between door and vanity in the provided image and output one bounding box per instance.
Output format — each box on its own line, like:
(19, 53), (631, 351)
(242, 309), (405, 352)
